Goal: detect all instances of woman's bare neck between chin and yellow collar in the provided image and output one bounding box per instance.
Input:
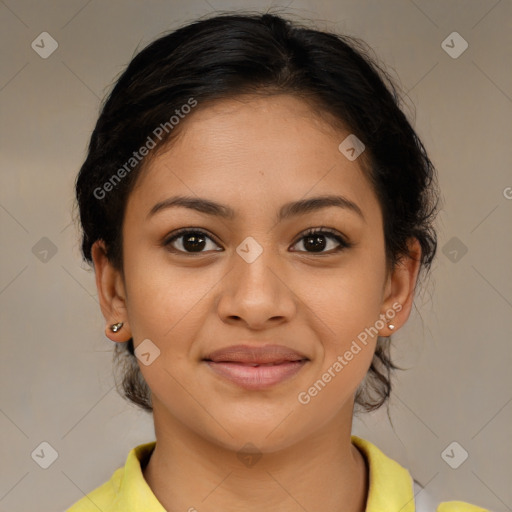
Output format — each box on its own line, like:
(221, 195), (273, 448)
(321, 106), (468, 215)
(143, 404), (369, 512)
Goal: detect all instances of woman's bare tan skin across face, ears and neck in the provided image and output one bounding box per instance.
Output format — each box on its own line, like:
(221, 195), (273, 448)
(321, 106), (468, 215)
(93, 95), (420, 512)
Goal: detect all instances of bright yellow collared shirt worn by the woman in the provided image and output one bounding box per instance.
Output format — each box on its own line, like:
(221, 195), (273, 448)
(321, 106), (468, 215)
(66, 436), (489, 512)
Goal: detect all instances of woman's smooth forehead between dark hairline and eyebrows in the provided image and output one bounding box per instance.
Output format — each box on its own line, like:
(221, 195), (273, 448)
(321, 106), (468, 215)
(129, 95), (380, 226)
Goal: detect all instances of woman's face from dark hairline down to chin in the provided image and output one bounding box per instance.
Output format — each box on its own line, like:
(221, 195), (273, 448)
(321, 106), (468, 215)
(97, 95), (414, 452)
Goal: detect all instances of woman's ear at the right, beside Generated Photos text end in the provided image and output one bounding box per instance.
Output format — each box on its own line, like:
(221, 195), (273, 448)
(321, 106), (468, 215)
(379, 238), (421, 336)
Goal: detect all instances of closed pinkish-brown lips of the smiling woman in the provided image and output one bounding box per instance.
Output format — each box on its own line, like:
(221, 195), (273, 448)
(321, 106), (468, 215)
(204, 345), (309, 391)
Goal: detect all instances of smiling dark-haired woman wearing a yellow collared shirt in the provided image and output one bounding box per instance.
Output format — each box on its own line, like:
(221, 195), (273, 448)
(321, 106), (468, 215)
(69, 14), (484, 512)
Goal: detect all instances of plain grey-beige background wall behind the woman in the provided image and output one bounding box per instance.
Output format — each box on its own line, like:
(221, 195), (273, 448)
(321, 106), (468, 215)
(0, 0), (512, 512)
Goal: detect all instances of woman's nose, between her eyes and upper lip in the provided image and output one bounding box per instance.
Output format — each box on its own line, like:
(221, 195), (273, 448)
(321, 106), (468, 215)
(217, 249), (297, 330)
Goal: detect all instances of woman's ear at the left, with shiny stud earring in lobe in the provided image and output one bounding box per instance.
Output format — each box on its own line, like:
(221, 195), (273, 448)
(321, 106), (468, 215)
(91, 240), (132, 342)
